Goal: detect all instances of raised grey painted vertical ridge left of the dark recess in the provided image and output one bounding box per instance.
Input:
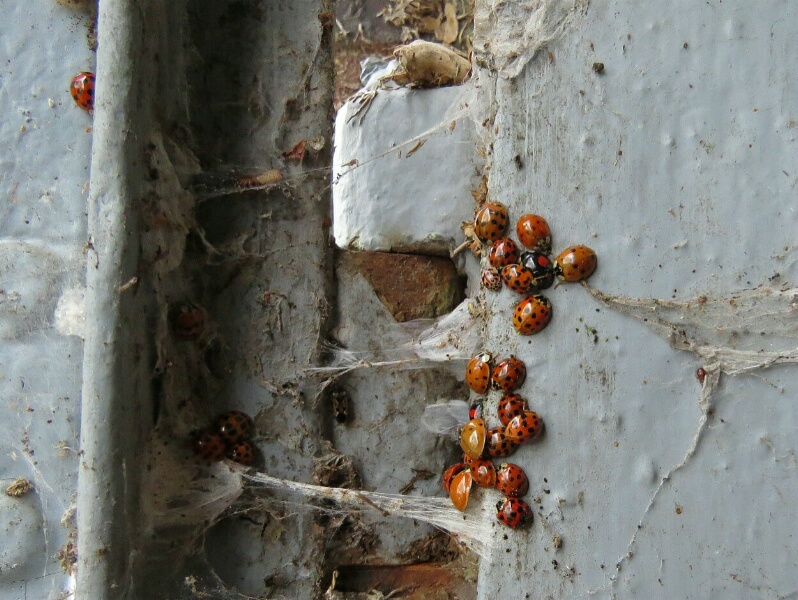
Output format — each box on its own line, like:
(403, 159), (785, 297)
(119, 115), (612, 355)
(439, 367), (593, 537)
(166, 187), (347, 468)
(75, 0), (152, 600)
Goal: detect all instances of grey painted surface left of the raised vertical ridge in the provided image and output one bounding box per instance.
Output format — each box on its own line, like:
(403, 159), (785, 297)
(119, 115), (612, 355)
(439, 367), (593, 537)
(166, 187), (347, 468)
(0, 2), (94, 599)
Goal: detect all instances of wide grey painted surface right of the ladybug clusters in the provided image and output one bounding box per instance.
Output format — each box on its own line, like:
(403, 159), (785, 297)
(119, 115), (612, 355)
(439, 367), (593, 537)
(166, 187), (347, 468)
(470, 1), (798, 598)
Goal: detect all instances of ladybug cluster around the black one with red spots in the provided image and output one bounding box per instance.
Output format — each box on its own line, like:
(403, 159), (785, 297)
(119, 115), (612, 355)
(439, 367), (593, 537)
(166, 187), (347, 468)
(474, 202), (598, 335)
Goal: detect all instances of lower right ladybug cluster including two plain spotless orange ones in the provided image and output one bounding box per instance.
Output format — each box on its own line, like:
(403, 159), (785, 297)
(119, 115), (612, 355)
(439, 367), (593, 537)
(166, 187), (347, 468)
(443, 352), (543, 529)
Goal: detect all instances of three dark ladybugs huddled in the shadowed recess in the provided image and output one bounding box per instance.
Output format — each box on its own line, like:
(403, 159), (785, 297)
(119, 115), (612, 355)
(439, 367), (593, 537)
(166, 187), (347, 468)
(192, 410), (257, 466)
